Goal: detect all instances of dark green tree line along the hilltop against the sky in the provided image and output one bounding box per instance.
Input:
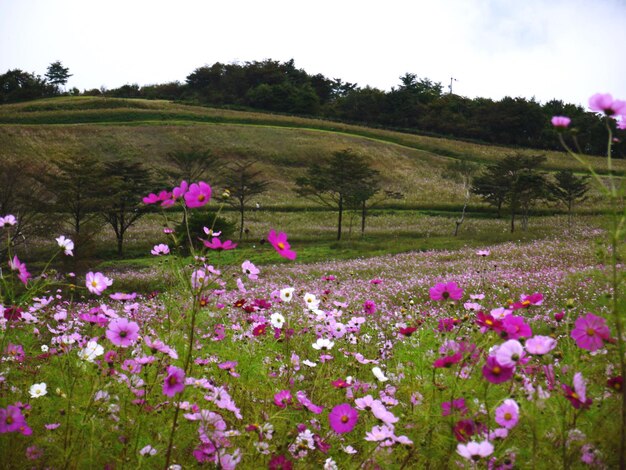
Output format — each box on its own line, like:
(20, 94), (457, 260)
(0, 59), (626, 158)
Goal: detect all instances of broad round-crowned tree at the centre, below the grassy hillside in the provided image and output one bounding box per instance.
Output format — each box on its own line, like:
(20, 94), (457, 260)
(296, 149), (379, 240)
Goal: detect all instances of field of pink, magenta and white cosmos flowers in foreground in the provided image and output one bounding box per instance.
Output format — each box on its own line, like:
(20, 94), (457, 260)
(0, 92), (626, 469)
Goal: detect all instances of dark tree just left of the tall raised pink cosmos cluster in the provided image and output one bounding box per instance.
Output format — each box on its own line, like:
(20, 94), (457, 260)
(101, 159), (154, 257)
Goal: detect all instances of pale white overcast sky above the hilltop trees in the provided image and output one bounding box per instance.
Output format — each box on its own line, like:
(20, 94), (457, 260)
(0, 0), (626, 106)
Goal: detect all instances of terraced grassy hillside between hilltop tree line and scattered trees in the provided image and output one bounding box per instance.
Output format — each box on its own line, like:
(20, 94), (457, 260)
(0, 97), (626, 207)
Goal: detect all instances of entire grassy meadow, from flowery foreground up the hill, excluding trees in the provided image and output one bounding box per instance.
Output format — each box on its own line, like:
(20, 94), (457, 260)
(0, 93), (626, 469)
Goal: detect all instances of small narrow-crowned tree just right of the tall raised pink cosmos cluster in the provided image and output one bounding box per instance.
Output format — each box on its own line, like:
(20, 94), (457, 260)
(222, 160), (269, 241)
